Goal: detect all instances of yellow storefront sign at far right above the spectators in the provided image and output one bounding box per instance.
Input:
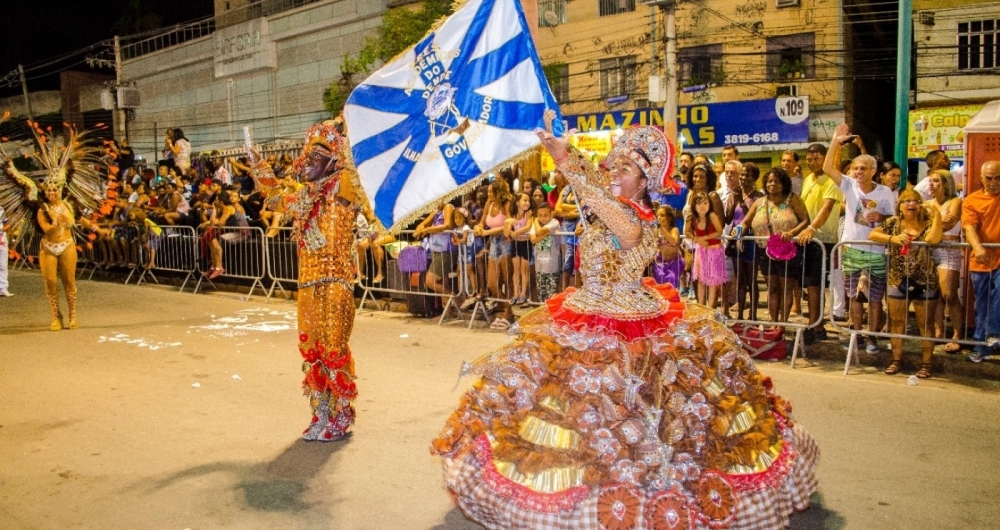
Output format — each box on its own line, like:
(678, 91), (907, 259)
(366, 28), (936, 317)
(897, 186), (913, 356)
(909, 105), (983, 158)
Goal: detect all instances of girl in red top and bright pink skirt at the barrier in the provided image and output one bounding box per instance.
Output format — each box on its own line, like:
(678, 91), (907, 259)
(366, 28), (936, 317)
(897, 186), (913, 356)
(684, 192), (726, 308)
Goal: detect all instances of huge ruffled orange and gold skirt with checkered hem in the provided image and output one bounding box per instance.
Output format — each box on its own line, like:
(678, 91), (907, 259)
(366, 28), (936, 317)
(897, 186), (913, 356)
(432, 281), (819, 530)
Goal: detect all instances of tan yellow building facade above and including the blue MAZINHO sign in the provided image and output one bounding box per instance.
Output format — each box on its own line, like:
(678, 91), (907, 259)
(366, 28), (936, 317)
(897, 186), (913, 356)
(536, 0), (845, 165)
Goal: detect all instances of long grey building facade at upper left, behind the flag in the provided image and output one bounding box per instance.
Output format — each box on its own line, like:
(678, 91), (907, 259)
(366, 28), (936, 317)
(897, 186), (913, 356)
(122, 0), (388, 160)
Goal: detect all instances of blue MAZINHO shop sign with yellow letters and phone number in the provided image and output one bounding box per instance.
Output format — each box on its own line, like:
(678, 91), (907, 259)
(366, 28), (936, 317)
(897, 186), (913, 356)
(565, 97), (809, 149)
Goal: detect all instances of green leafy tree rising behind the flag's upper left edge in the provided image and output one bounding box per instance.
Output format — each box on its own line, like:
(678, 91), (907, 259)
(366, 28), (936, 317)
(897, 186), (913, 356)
(323, 0), (453, 116)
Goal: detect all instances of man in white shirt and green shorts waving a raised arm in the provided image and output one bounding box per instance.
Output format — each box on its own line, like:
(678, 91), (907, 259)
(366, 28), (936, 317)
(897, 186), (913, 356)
(823, 123), (896, 354)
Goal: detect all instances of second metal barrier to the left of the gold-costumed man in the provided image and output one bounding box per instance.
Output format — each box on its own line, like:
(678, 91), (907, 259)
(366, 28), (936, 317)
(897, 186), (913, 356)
(194, 226), (267, 300)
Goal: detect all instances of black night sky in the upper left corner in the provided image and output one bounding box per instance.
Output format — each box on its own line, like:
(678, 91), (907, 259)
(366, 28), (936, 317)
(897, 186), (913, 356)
(0, 0), (214, 97)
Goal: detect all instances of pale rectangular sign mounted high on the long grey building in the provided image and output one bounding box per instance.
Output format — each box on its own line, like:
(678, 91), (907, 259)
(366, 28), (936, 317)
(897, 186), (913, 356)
(215, 18), (278, 77)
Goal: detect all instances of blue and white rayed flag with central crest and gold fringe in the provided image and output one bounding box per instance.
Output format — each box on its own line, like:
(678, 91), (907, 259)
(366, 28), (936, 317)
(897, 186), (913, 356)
(344, 0), (562, 229)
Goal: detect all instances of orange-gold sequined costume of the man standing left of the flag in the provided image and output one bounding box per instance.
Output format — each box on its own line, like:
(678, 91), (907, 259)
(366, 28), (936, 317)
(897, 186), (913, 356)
(251, 122), (359, 441)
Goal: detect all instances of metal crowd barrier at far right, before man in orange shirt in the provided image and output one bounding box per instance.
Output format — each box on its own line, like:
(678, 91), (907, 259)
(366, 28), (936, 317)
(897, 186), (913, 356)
(833, 237), (1000, 375)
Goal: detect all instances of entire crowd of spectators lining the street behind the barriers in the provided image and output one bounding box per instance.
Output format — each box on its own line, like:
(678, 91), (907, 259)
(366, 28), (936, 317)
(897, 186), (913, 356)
(31, 126), (1000, 377)
